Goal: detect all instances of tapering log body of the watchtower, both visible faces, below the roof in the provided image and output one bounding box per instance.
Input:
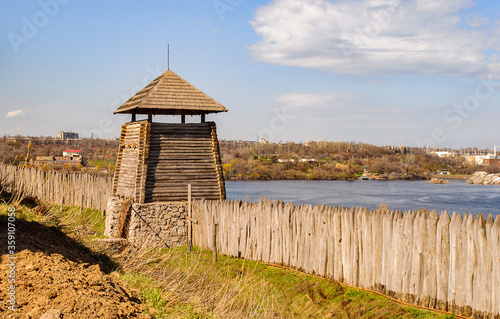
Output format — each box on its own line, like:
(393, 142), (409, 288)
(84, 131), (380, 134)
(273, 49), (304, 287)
(113, 121), (226, 203)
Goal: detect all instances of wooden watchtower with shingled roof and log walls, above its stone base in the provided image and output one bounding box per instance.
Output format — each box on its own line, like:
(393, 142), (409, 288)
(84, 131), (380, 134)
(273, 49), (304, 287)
(113, 70), (227, 203)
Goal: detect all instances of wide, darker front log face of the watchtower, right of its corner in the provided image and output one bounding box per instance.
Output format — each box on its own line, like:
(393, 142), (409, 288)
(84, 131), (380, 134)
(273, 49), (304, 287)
(145, 122), (226, 203)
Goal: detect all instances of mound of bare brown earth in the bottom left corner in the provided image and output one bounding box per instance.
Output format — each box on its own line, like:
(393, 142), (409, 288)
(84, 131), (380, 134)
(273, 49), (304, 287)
(0, 219), (150, 319)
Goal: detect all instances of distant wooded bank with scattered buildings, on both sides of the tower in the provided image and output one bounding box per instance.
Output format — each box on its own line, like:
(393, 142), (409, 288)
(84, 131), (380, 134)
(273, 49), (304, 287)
(0, 131), (500, 180)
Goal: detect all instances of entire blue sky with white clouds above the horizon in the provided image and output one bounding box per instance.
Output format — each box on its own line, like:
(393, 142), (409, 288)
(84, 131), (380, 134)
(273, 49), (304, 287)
(0, 0), (500, 149)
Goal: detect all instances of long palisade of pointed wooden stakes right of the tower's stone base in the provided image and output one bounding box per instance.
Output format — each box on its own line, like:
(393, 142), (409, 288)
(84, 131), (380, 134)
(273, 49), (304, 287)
(193, 200), (500, 318)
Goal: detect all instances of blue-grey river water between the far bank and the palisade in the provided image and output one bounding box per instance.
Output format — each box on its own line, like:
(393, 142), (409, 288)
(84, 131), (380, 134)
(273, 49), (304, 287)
(226, 180), (500, 217)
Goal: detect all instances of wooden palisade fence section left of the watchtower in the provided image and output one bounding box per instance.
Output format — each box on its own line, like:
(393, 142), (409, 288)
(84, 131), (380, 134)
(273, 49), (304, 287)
(0, 164), (113, 211)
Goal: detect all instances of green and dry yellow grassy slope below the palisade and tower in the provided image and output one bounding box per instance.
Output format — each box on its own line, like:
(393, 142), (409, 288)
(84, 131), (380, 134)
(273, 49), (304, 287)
(0, 198), (451, 318)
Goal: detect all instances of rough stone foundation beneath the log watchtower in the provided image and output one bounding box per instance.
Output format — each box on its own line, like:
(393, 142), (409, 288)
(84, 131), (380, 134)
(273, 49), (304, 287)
(104, 197), (186, 247)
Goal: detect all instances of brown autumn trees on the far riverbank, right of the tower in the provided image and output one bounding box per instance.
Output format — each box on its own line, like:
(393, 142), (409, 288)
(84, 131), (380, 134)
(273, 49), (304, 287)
(220, 141), (476, 180)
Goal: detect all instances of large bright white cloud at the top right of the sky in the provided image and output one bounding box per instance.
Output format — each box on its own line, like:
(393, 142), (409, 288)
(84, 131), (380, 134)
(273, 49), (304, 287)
(249, 0), (500, 76)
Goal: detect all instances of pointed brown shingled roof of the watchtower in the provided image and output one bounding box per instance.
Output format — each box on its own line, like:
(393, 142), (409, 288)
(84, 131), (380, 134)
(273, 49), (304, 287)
(113, 70), (227, 115)
